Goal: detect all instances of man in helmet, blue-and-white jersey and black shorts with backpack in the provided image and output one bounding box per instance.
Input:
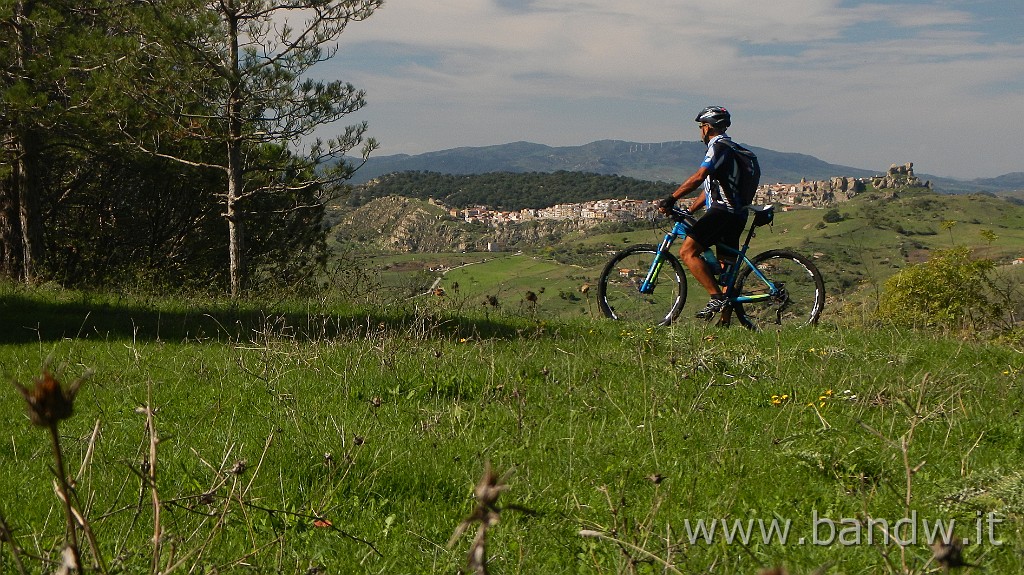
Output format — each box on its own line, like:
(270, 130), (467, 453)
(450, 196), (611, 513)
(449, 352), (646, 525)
(658, 105), (748, 319)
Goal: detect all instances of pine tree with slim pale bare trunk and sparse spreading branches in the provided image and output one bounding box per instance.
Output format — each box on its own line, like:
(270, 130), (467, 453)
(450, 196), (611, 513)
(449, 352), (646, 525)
(119, 0), (381, 297)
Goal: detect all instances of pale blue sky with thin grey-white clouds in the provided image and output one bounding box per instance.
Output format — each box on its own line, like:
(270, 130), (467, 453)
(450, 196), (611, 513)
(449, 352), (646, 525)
(316, 0), (1024, 179)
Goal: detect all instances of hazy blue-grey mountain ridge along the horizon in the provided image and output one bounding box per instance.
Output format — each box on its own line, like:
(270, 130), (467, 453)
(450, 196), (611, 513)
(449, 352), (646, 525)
(351, 140), (1024, 193)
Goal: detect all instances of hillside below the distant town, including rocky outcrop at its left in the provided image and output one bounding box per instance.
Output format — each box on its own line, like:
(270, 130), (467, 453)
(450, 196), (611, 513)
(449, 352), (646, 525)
(332, 183), (1024, 315)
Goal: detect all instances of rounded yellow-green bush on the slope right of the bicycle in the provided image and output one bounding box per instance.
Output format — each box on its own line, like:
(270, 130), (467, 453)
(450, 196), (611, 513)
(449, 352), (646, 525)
(879, 248), (1001, 329)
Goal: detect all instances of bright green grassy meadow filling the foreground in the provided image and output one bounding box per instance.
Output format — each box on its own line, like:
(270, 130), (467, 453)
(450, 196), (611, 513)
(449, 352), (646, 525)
(0, 284), (1024, 574)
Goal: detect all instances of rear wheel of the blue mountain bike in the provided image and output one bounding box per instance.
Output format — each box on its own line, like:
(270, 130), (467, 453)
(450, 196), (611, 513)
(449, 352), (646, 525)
(734, 250), (825, 328)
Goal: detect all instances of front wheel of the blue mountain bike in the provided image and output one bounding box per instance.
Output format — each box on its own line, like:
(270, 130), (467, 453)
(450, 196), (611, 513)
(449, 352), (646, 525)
(597, 245), (686, 325)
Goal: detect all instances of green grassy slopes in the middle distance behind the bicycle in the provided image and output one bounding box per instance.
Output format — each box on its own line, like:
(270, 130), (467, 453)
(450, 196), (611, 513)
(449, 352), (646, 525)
(356, 189), (1024, 317)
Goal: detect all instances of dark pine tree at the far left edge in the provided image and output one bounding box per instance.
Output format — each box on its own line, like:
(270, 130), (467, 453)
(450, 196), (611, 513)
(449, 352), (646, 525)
(0, 0), (138, 282)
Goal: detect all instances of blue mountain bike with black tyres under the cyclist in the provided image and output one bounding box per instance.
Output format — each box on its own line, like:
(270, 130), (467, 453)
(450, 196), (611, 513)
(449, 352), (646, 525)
(597, 206), (825, 329)
